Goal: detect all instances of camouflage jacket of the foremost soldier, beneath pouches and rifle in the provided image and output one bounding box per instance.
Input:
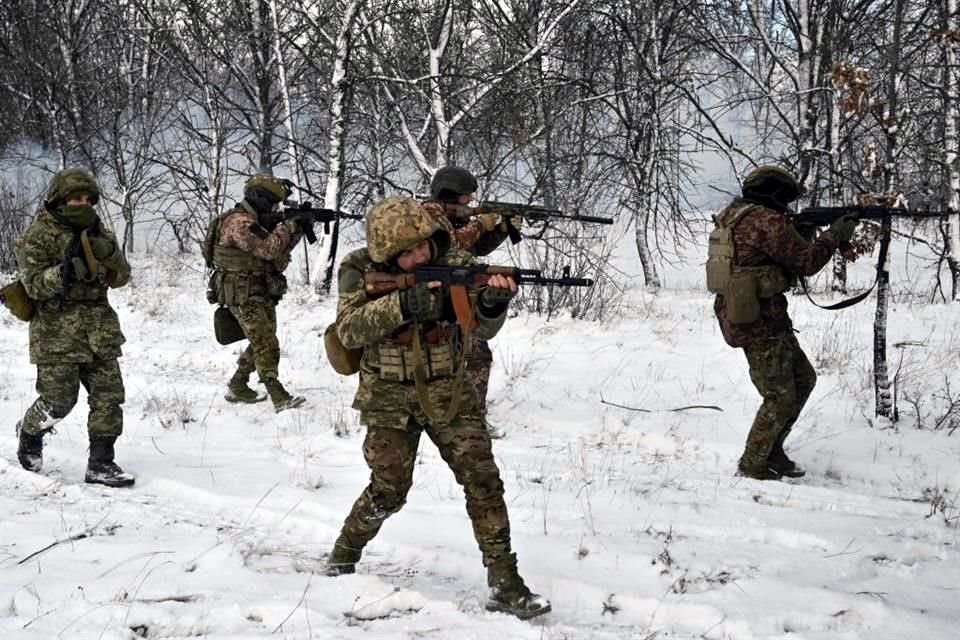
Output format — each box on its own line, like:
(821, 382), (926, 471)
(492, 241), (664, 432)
(337, 249), (506, 428)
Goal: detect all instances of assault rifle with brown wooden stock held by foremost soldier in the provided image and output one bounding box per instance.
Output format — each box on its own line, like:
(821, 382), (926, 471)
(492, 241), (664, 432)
(363, 264), (593, 298)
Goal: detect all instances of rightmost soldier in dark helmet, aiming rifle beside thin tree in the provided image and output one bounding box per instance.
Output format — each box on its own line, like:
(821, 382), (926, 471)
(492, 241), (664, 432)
(708, 165), (857, 480)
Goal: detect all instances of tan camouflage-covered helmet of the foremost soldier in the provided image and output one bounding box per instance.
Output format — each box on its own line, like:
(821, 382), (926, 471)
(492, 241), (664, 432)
(367, 196), (450, 263)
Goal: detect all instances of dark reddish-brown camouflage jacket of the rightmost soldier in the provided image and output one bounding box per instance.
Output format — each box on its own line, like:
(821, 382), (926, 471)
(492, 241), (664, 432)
(713, 198), (840, 347)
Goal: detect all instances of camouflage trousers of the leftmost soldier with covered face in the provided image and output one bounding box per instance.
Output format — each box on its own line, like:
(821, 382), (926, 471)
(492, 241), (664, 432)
(20, 358), (125, 438)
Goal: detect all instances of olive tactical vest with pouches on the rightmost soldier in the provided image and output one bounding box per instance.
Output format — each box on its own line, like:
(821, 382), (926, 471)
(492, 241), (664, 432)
(707, 203), (792, 324)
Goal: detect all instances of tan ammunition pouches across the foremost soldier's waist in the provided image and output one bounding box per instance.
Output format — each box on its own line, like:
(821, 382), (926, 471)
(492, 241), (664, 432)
(364, 325), (462, 382)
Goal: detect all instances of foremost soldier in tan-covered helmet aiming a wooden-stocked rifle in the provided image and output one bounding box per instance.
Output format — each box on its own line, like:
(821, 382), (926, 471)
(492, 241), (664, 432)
(327, 197), (550, 619)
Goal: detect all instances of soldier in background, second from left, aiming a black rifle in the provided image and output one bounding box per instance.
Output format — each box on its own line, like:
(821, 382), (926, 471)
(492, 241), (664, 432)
(208, 173), (306, 412)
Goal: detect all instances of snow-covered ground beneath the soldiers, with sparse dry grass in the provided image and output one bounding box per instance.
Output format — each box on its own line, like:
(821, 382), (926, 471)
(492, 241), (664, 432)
(0, 244), (960, 640)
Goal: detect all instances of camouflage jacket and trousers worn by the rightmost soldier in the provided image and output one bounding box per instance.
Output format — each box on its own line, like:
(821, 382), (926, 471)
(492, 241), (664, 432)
(713, 198), (840, 476)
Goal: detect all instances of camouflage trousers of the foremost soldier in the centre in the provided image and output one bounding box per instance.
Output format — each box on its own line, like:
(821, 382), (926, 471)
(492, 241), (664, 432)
(336, 418), (513, 566)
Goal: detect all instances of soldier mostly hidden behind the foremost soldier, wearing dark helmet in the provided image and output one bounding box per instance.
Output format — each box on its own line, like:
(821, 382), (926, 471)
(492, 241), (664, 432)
(423, 166), (521, 438)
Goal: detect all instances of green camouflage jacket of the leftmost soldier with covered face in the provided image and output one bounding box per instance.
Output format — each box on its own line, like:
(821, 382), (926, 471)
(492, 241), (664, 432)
(15, 209), (130, 364)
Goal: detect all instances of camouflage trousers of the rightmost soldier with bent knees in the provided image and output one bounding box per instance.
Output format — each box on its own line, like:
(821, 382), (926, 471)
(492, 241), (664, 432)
(742, 332), (817, 467)
